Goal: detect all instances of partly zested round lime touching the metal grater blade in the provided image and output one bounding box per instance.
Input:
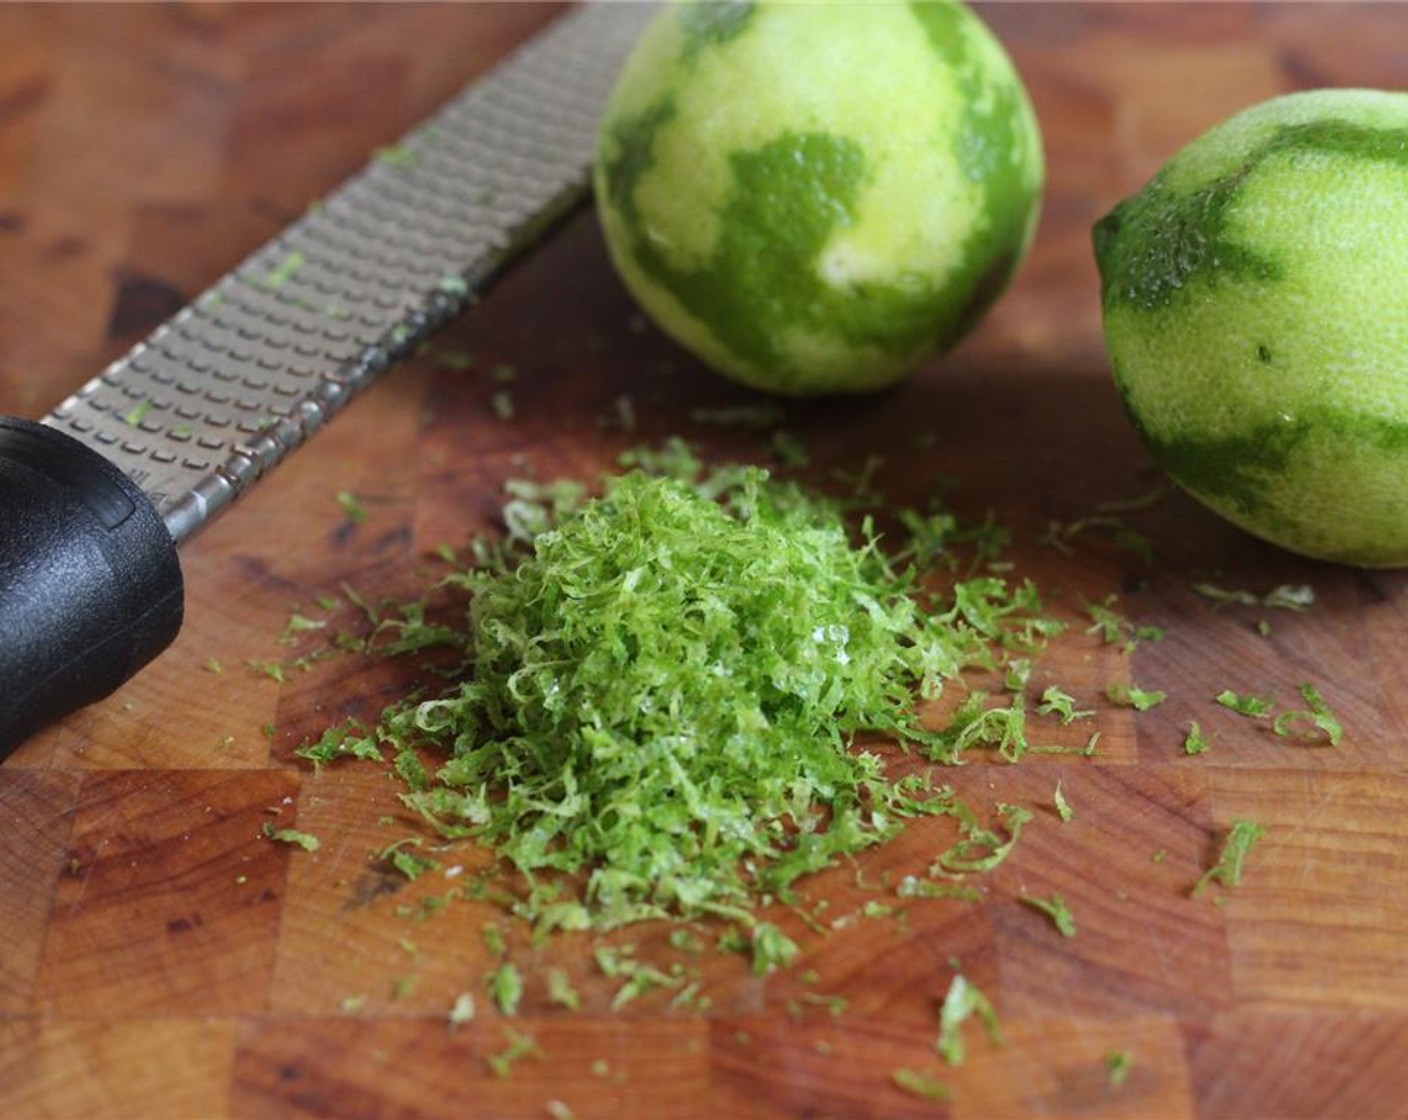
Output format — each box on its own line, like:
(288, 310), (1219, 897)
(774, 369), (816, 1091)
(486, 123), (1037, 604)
(596, 3), (1042, 394)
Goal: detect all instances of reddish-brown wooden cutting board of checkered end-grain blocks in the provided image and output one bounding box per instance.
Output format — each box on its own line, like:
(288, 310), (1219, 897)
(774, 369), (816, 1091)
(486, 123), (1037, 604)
(0, 3), (1408, 1119)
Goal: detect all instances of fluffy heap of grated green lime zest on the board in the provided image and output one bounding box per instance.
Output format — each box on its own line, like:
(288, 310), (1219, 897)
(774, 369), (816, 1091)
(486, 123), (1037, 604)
(298, 441), (1060, 952)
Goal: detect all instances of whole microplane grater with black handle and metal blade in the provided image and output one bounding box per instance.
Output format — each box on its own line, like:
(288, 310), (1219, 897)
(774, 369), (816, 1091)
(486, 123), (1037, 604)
(0, 0), (656, 758)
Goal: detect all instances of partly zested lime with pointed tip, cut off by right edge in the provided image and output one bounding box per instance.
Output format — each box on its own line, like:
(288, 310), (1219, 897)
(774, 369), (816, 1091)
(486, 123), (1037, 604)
(1094, 90), (1408, 566)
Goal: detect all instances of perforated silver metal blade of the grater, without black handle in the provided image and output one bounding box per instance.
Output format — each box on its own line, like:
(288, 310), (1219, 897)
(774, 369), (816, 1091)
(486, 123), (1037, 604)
(44, 3), (655, 541)
